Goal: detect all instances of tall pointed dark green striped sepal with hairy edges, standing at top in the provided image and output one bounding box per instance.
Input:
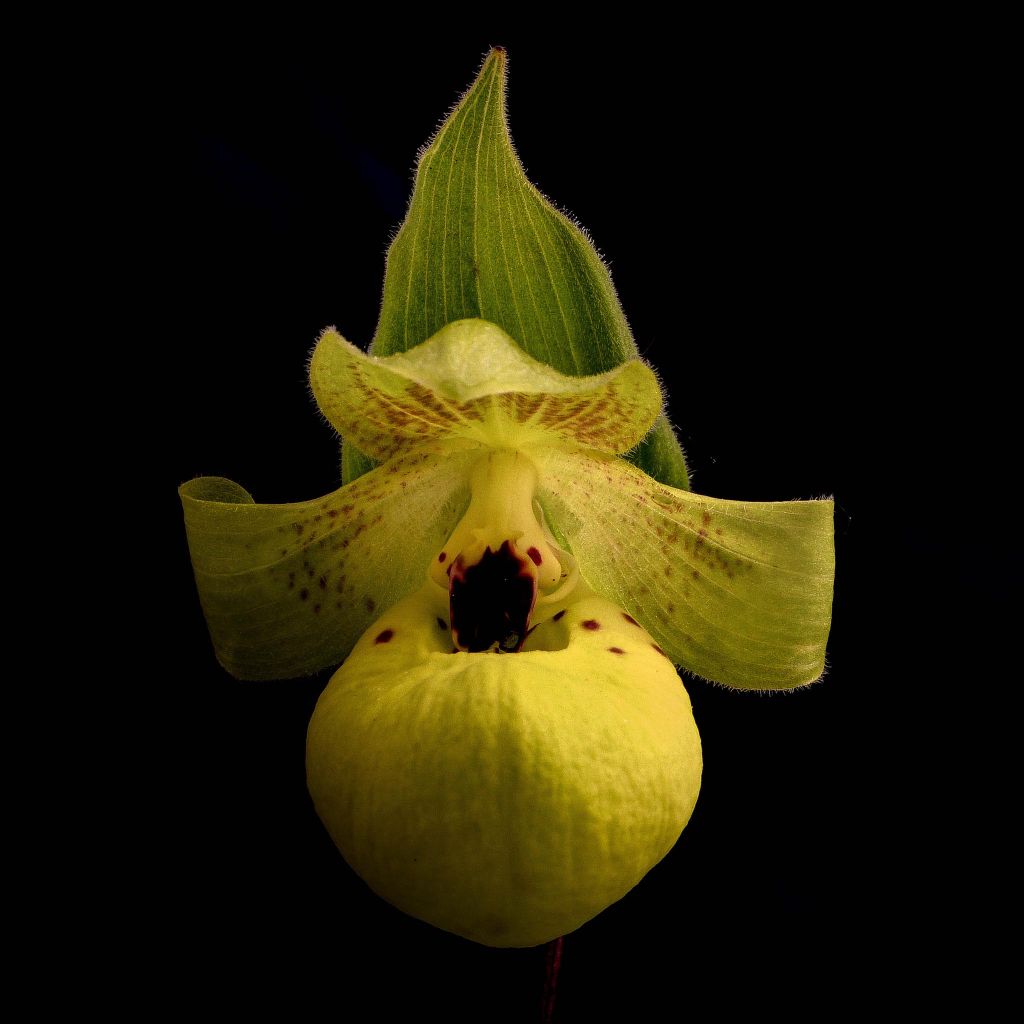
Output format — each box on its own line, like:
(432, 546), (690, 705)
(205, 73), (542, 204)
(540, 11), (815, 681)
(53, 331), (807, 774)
(344, 50), (686, 482)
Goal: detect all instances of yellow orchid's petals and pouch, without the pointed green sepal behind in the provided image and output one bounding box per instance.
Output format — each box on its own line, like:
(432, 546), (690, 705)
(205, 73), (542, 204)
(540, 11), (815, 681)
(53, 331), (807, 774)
(180, 46), (834, 946)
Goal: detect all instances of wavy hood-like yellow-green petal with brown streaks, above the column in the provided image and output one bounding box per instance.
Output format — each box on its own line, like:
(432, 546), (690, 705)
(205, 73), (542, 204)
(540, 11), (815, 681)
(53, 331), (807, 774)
(309, 319), (662, 459)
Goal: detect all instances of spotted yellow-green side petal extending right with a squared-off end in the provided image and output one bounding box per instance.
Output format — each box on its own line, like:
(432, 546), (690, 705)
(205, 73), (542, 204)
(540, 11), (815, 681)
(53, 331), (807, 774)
(538, 450), (835, 689)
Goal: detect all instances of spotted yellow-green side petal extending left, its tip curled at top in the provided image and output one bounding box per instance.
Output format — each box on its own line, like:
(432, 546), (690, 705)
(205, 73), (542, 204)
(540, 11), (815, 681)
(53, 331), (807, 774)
(179, 443), (479, 679)
